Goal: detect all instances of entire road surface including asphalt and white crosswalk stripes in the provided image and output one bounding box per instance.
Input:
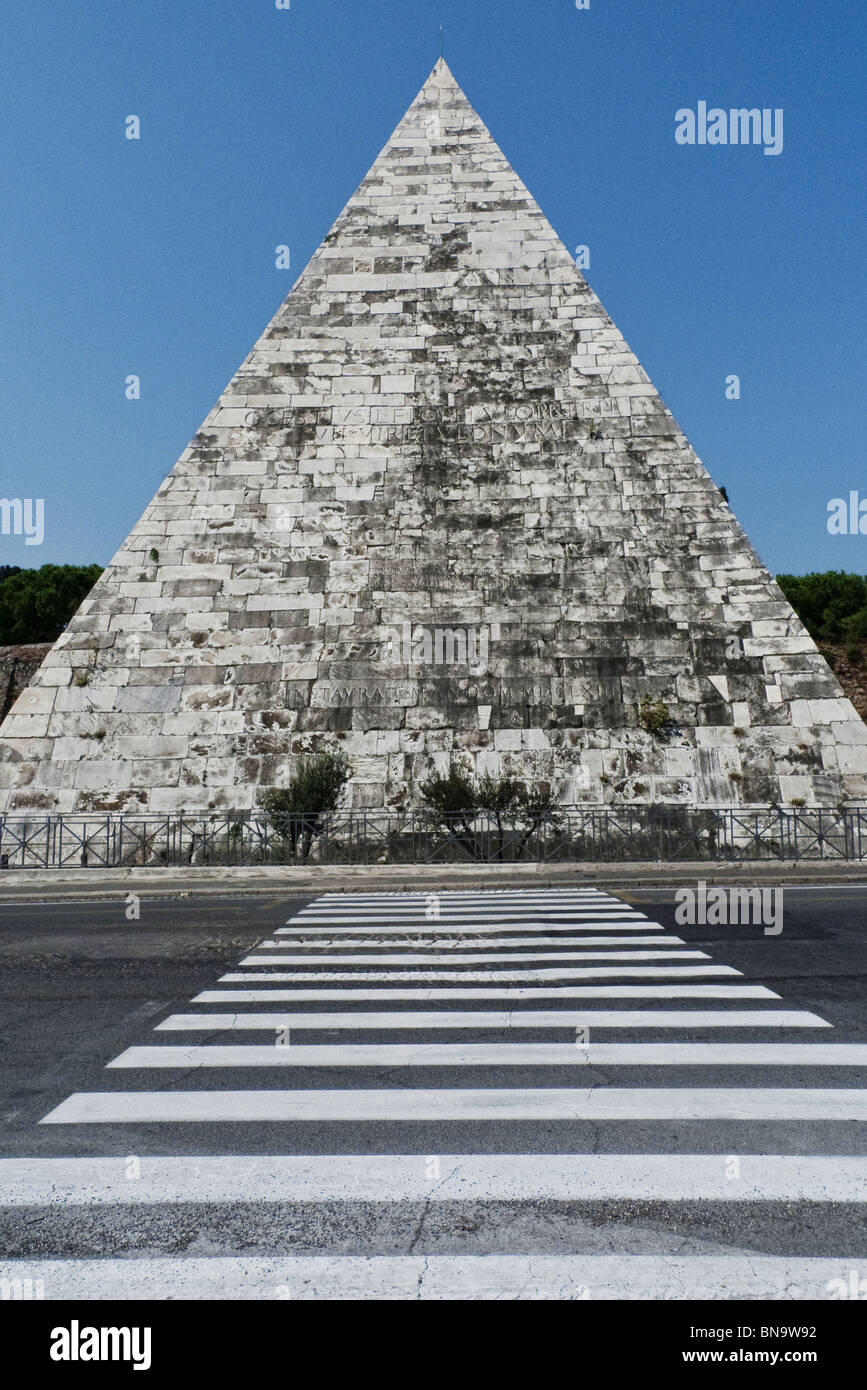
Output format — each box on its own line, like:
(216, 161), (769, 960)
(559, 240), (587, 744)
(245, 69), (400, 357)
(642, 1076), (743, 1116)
(0, 887), (867, 1300)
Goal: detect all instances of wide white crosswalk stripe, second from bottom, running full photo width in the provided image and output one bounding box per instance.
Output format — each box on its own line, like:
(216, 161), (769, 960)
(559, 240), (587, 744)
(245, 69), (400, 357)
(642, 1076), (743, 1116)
(0, 1154), (867, 1206)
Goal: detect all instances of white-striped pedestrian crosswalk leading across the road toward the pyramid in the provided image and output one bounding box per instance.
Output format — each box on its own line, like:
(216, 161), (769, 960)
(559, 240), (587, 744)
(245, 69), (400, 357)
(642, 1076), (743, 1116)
(0, 888), (867, 1298)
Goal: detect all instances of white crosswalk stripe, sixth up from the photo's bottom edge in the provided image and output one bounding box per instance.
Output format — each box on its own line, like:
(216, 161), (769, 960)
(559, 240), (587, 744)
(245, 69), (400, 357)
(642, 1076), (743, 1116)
(190, 983), (779, 1004)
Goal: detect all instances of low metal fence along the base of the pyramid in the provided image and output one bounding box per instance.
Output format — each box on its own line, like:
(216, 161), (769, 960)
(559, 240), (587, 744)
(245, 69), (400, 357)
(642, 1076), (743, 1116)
(0, 806), (867, 870)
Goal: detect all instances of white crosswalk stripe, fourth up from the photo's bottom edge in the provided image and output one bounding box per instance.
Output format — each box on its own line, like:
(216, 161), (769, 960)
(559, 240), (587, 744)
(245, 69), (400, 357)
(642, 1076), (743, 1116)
(108, 1043), (867, 1073)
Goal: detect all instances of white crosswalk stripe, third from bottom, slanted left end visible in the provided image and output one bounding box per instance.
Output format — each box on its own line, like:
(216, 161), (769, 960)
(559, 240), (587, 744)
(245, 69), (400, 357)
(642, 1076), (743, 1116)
(39, 1086), (867, 1125)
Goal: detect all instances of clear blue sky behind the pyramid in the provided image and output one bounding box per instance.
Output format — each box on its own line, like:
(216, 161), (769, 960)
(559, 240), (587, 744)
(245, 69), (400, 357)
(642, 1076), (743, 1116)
(0, 0), (867, 573)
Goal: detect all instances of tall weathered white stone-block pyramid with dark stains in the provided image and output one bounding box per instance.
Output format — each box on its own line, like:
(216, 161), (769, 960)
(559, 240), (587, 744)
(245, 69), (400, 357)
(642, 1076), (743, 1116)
(0, 61), (867, 813)
